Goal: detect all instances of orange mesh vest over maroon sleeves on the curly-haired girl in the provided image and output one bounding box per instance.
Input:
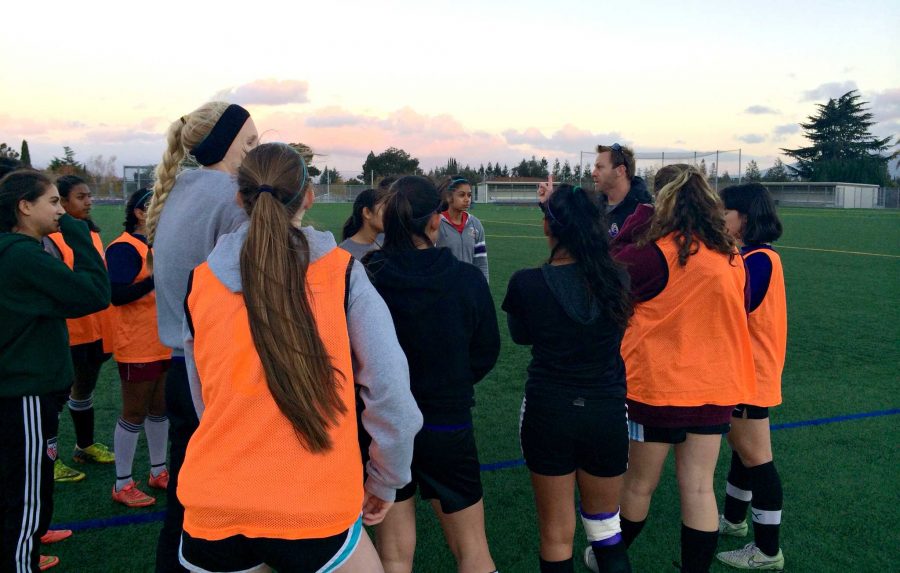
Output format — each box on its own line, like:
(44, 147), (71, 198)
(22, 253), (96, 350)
(622, 235), (756, 406)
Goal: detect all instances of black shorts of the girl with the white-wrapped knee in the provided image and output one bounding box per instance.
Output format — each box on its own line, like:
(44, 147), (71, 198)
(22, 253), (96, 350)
(519, 387), (628, 477)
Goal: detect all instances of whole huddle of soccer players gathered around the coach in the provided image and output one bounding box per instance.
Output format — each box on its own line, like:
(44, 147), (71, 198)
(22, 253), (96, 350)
(0, 102), (787, 573)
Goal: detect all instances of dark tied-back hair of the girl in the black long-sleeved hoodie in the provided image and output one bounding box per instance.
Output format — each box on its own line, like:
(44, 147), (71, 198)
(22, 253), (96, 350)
(381, 175), (441, 253)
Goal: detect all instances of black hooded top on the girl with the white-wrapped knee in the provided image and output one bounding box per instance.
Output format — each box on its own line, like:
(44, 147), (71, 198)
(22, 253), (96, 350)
(502, 264), (627, 399)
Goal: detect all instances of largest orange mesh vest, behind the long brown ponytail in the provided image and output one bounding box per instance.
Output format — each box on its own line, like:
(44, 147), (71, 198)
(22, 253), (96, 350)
(178, 248), (363, 540)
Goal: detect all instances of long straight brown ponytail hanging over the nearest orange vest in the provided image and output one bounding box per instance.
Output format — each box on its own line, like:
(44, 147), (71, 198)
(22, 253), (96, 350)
(237, 143), (347, 452)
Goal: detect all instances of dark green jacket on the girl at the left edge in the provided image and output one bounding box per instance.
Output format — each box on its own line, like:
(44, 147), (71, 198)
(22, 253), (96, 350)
(0, 215), (110, 397)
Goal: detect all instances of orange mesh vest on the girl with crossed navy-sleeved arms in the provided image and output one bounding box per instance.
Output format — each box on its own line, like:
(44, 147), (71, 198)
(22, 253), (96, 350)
(107, 232), (172, 364)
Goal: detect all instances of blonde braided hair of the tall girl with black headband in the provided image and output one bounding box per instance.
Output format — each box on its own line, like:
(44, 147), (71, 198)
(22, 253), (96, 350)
(147, 101), (228, 245)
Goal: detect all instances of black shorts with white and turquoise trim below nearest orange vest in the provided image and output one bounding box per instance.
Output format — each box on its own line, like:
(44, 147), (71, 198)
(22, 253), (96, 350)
(178, 519), (365, 573)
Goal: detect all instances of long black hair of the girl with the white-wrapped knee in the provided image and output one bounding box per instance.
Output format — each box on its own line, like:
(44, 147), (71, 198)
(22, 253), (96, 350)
(543, 184), (632, 330)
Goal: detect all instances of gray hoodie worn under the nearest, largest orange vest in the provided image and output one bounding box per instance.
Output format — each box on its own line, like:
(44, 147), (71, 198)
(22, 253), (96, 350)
(183, 223), (422, 501)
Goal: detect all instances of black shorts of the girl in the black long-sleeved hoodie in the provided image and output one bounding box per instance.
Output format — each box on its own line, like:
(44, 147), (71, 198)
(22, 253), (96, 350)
(395, 424), (484, 513)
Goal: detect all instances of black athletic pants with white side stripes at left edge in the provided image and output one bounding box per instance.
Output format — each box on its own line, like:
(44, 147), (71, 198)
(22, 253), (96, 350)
(0, 394), (59, 573)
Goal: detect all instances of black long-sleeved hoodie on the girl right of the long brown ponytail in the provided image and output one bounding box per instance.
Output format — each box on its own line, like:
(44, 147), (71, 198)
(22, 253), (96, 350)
(367, 248), (500, 425)
